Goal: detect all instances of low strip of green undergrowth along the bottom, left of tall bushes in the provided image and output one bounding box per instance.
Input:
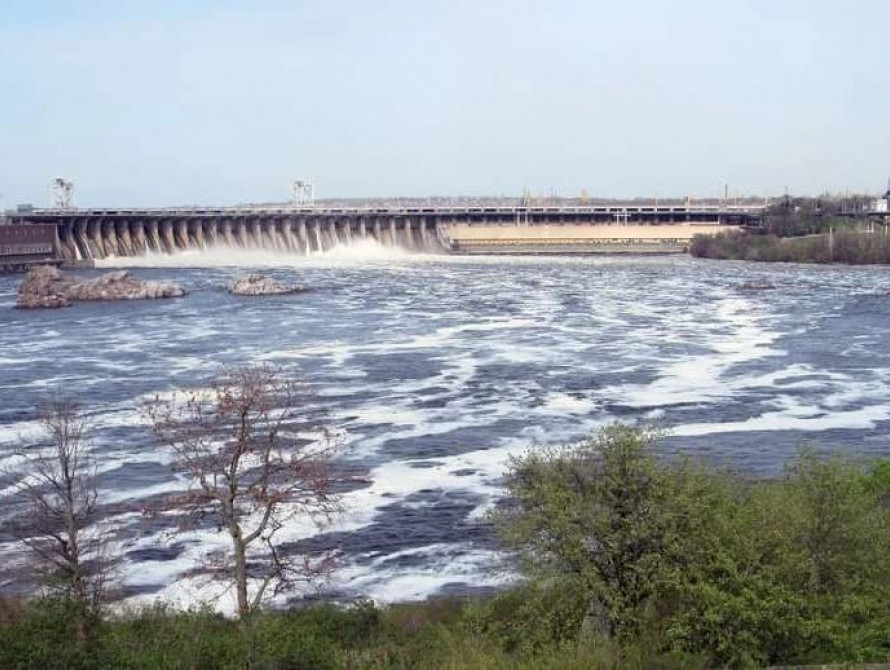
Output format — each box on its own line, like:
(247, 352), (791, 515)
(0, 588), (704, 670)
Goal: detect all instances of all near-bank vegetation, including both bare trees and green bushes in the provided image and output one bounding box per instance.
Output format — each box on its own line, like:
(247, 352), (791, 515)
(0, 367), (890, 668)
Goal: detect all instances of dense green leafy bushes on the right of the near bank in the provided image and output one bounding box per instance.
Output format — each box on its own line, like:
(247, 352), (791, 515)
(501, 426), (890, 666)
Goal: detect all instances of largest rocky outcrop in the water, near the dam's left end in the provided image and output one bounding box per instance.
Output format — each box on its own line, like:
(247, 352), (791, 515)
(16, 266), (185, 309)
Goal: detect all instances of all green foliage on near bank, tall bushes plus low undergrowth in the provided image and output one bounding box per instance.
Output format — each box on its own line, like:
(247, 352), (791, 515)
(0, 426), (890, 668)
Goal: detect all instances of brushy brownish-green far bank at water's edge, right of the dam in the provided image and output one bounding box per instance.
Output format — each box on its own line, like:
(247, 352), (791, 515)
(689, 229), (890, 265)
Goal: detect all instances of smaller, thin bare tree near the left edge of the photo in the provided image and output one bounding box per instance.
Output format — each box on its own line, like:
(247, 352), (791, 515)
(9, 399), (109, 639)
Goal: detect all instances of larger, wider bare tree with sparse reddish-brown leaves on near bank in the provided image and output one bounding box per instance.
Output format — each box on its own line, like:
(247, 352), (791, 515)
(148, 365), (339, 619)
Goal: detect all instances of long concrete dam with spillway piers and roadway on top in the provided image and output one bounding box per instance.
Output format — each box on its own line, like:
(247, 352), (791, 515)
(6, 204), (764, 261)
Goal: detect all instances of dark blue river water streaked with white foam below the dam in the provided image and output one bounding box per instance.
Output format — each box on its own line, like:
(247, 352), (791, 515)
(0, 249), (890, 616)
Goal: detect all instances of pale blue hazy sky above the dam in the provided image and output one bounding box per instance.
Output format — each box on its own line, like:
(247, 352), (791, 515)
(0, 0), (890, 208)
